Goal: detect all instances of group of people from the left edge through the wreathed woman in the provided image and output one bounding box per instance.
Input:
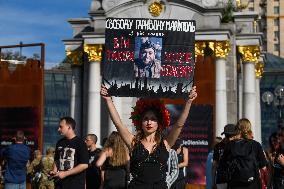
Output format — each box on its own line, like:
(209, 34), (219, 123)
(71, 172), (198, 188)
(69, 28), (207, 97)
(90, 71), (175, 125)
(1, 86), (197, 189)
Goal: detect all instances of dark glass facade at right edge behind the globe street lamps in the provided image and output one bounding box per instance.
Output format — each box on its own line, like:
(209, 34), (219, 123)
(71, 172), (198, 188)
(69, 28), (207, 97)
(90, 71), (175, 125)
(260, 54), (284, 148)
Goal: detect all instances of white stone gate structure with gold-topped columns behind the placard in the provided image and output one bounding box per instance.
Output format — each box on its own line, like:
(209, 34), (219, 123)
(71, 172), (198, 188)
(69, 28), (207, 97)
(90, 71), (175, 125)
(63, 0), (263, 184)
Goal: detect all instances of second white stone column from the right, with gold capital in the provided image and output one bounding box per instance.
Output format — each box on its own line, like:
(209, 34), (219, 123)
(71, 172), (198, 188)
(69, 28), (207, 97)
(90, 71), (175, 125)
(238, 46), (259, 135)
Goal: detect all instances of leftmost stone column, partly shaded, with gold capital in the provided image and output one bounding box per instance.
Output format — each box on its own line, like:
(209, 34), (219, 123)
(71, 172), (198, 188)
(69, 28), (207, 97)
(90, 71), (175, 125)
(66, 50), (83, 136)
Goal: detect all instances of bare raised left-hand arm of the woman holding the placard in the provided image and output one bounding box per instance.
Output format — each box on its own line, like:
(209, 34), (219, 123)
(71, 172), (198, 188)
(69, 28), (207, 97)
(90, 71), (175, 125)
(101, 85), (134, 149)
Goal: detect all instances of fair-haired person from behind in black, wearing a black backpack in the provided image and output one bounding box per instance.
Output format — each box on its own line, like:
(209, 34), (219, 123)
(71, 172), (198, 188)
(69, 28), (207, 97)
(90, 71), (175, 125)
(221, 118), (267, 189)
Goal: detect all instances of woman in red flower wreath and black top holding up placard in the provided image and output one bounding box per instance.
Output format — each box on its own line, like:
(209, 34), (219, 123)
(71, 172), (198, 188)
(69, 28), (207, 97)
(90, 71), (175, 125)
(101, 85), (197, 189)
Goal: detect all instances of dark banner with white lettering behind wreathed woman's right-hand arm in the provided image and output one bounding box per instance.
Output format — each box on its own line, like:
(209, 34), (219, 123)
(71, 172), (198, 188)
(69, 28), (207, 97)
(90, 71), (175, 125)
(167, 104), (213, 185)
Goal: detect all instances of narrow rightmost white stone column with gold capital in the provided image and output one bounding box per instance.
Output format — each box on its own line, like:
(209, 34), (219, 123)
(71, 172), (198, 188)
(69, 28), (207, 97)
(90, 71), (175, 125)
(254, 62), (264, 143)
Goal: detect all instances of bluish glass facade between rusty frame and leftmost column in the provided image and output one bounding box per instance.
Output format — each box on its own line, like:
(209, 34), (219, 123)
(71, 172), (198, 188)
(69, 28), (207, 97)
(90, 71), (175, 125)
(43, 68), (72, 152)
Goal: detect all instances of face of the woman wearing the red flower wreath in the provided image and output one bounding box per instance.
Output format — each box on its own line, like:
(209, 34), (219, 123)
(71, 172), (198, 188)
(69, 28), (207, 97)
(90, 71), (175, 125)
(142, 110), (159, 134)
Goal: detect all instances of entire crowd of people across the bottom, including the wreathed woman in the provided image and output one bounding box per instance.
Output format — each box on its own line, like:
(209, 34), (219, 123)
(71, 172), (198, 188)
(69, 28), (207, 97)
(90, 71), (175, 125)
(1, 85), (284, 189)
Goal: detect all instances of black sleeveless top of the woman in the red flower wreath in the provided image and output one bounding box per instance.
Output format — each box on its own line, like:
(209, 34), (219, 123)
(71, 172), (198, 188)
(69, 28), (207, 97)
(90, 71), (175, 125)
(129, 141), (169, 189)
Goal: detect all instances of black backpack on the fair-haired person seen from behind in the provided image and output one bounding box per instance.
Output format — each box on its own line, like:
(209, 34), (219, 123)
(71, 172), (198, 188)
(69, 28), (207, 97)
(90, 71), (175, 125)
(227, 139), (259, 184)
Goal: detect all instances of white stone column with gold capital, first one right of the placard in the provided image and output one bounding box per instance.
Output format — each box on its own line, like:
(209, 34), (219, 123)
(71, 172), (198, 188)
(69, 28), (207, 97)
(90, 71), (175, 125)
(215, 41), (230, 136)
